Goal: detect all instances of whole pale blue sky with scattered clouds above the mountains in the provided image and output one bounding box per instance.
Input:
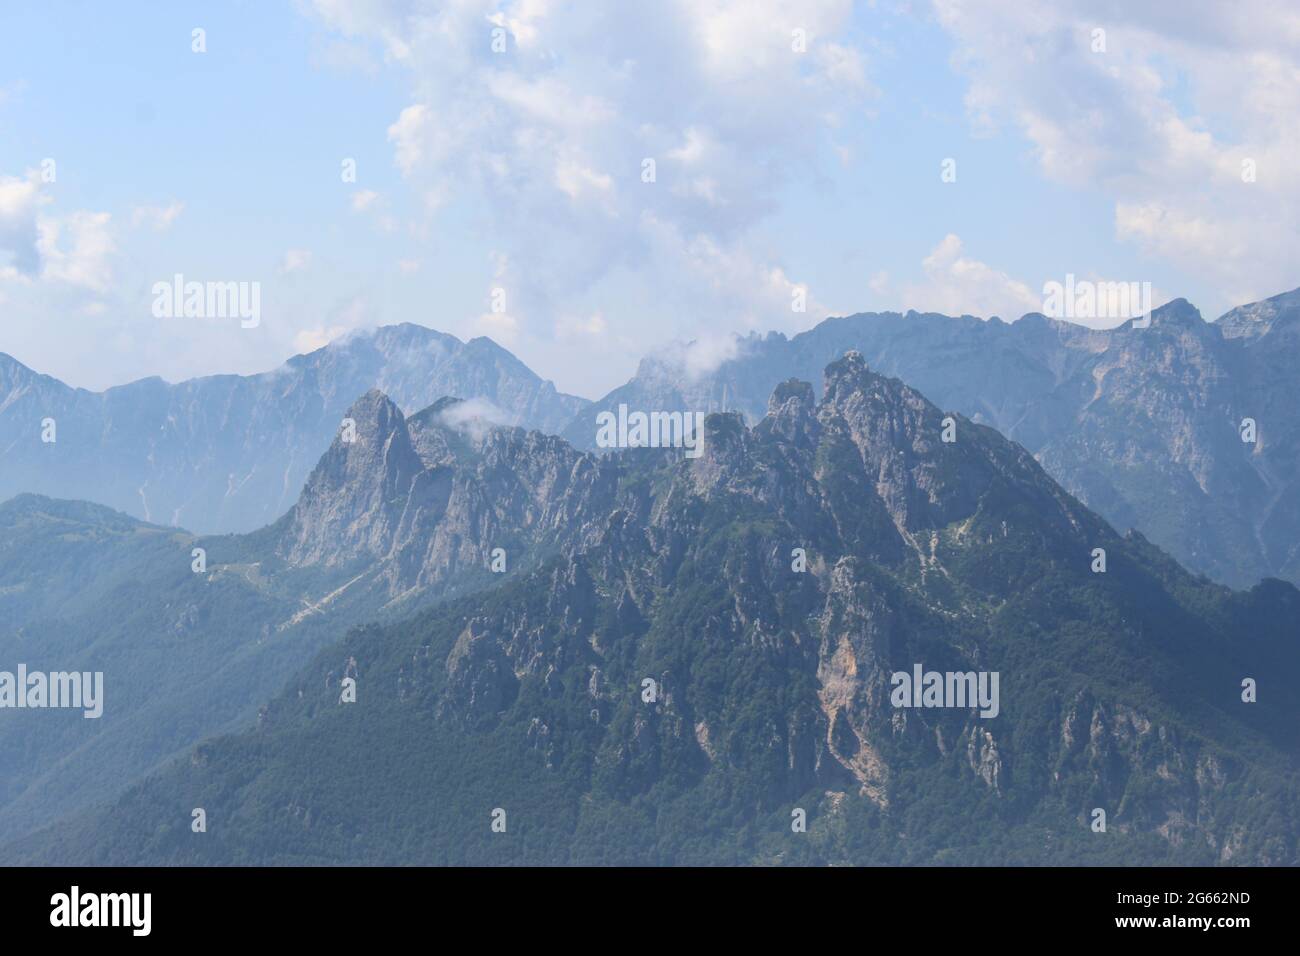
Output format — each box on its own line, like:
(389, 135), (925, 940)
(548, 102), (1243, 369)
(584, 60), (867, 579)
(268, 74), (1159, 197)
(0, 0), (1300, 398)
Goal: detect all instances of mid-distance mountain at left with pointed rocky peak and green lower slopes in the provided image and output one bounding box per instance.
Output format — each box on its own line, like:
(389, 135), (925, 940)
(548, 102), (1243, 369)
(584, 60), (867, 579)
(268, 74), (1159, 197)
(0, 390), (605, 839)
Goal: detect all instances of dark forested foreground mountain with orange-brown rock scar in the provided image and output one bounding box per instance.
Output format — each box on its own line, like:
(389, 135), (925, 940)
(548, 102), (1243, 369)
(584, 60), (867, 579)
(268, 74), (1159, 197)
(12, 352), (1300, 865)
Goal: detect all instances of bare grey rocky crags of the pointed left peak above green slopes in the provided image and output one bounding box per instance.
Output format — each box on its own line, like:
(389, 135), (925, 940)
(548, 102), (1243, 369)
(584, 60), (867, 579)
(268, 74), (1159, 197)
(276, 390), (619, 598)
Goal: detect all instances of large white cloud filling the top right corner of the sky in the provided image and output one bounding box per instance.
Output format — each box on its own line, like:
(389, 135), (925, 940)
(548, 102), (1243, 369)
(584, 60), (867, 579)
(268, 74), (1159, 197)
(933, 0), (1300, 300)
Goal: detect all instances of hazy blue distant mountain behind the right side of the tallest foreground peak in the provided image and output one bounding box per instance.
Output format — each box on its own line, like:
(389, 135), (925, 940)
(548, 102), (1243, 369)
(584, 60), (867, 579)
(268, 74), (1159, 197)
(562, 290), (1300, 587)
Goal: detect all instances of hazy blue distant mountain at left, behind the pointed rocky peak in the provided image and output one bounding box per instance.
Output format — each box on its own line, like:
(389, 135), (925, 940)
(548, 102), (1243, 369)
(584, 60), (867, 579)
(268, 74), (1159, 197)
(0, 324), (586, 533)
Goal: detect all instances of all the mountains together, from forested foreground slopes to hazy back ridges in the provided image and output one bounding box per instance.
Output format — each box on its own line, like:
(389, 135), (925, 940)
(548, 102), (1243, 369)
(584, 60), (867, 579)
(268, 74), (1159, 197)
(0, 293), (1300, 864)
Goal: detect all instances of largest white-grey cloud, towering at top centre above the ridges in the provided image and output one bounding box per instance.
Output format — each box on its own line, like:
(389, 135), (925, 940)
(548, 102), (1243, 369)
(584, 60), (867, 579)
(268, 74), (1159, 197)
(304, 0), (875, 358)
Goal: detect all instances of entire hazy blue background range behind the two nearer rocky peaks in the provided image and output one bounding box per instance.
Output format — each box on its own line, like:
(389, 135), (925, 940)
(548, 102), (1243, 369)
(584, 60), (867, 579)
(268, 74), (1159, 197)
(0, 290), (1300, 587)
